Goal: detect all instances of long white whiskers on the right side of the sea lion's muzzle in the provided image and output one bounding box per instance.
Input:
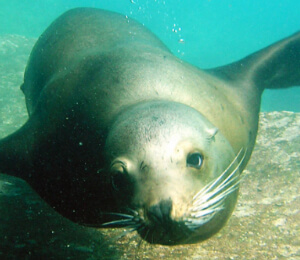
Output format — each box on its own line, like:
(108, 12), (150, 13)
(185, 148), (247, 230)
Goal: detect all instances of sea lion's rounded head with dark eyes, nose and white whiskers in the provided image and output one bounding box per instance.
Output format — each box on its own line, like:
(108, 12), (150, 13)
(105, 101), (243, 245)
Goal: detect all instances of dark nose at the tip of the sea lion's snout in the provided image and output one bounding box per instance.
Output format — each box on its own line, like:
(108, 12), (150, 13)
(147, 199), (172, 224)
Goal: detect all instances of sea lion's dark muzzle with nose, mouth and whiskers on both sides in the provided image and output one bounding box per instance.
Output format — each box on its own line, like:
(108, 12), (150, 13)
(104, 149), (247, 245)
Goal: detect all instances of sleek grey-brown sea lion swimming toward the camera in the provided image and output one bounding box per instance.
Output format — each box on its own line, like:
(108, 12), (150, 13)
(0, 8), (300, 245)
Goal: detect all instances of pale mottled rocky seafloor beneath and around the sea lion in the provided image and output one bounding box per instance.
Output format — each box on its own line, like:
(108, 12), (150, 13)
(0, 35), (300, 259)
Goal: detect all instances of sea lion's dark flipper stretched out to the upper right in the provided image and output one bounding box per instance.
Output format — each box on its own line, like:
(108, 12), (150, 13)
(207, 32), (300, 91)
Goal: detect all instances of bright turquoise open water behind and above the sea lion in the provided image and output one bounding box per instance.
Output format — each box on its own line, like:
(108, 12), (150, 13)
(0, 0), (300, 112)
